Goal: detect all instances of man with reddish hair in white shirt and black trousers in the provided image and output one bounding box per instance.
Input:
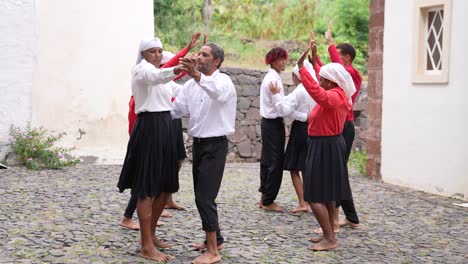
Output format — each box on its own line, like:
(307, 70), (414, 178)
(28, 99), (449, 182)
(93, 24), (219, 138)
(258, 47), (288, 212)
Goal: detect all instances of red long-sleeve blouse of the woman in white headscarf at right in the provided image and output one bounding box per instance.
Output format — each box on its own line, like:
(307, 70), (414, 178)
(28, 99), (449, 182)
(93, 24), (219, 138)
(299, 67), (351, 136)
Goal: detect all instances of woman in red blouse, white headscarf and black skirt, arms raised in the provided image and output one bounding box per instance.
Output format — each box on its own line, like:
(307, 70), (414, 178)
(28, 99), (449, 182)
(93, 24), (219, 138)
(297, 42), (356, 251)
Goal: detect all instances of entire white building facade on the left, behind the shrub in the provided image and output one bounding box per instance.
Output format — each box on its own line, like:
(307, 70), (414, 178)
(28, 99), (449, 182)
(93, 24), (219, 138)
(0, 0), (154, 163)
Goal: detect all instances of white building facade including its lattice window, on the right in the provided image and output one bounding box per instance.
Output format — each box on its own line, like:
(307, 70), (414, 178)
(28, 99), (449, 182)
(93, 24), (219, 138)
(381, 0), (468, 199)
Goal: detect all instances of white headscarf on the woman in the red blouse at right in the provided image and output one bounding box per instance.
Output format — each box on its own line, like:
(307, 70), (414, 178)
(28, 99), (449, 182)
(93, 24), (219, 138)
(319, 63), (356, 105)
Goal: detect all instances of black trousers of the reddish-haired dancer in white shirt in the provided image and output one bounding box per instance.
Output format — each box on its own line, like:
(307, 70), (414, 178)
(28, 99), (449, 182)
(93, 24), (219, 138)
(258, 117), (285, 205)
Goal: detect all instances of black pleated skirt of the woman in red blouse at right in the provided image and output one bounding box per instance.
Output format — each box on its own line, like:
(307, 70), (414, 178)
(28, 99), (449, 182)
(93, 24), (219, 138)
(304, 135), (352, 203)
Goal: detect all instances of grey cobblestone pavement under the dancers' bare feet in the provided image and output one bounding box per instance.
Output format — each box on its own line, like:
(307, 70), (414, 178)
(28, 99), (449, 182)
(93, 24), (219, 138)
(0, 163), (468, 263)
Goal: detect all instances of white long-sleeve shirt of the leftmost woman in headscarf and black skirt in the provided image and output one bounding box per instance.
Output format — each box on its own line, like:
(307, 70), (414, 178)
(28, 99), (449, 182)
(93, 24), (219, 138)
(132, 59), (178, 114)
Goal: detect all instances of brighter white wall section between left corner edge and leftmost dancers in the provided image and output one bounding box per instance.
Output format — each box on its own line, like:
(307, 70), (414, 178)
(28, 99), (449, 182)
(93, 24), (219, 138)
(31, 0), (154, 163)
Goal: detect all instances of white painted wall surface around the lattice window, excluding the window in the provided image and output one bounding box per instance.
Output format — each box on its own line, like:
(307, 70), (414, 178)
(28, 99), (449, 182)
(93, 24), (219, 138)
(381, 0), (468, 199)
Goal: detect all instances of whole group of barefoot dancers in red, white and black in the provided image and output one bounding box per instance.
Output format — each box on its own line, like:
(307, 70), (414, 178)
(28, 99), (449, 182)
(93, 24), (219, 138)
(117, 23), (361, 264)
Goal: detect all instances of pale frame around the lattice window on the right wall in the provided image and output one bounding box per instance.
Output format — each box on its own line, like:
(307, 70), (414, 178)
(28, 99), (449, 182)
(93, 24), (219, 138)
(413, 0), (452, 83)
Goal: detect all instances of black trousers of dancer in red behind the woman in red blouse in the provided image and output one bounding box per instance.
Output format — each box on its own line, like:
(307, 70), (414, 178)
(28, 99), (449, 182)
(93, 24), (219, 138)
(336, 121), (359, 224)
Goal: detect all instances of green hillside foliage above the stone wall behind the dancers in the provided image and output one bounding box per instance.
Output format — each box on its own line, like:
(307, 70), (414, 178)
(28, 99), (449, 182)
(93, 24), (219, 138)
(154, 0), (370, 70)
